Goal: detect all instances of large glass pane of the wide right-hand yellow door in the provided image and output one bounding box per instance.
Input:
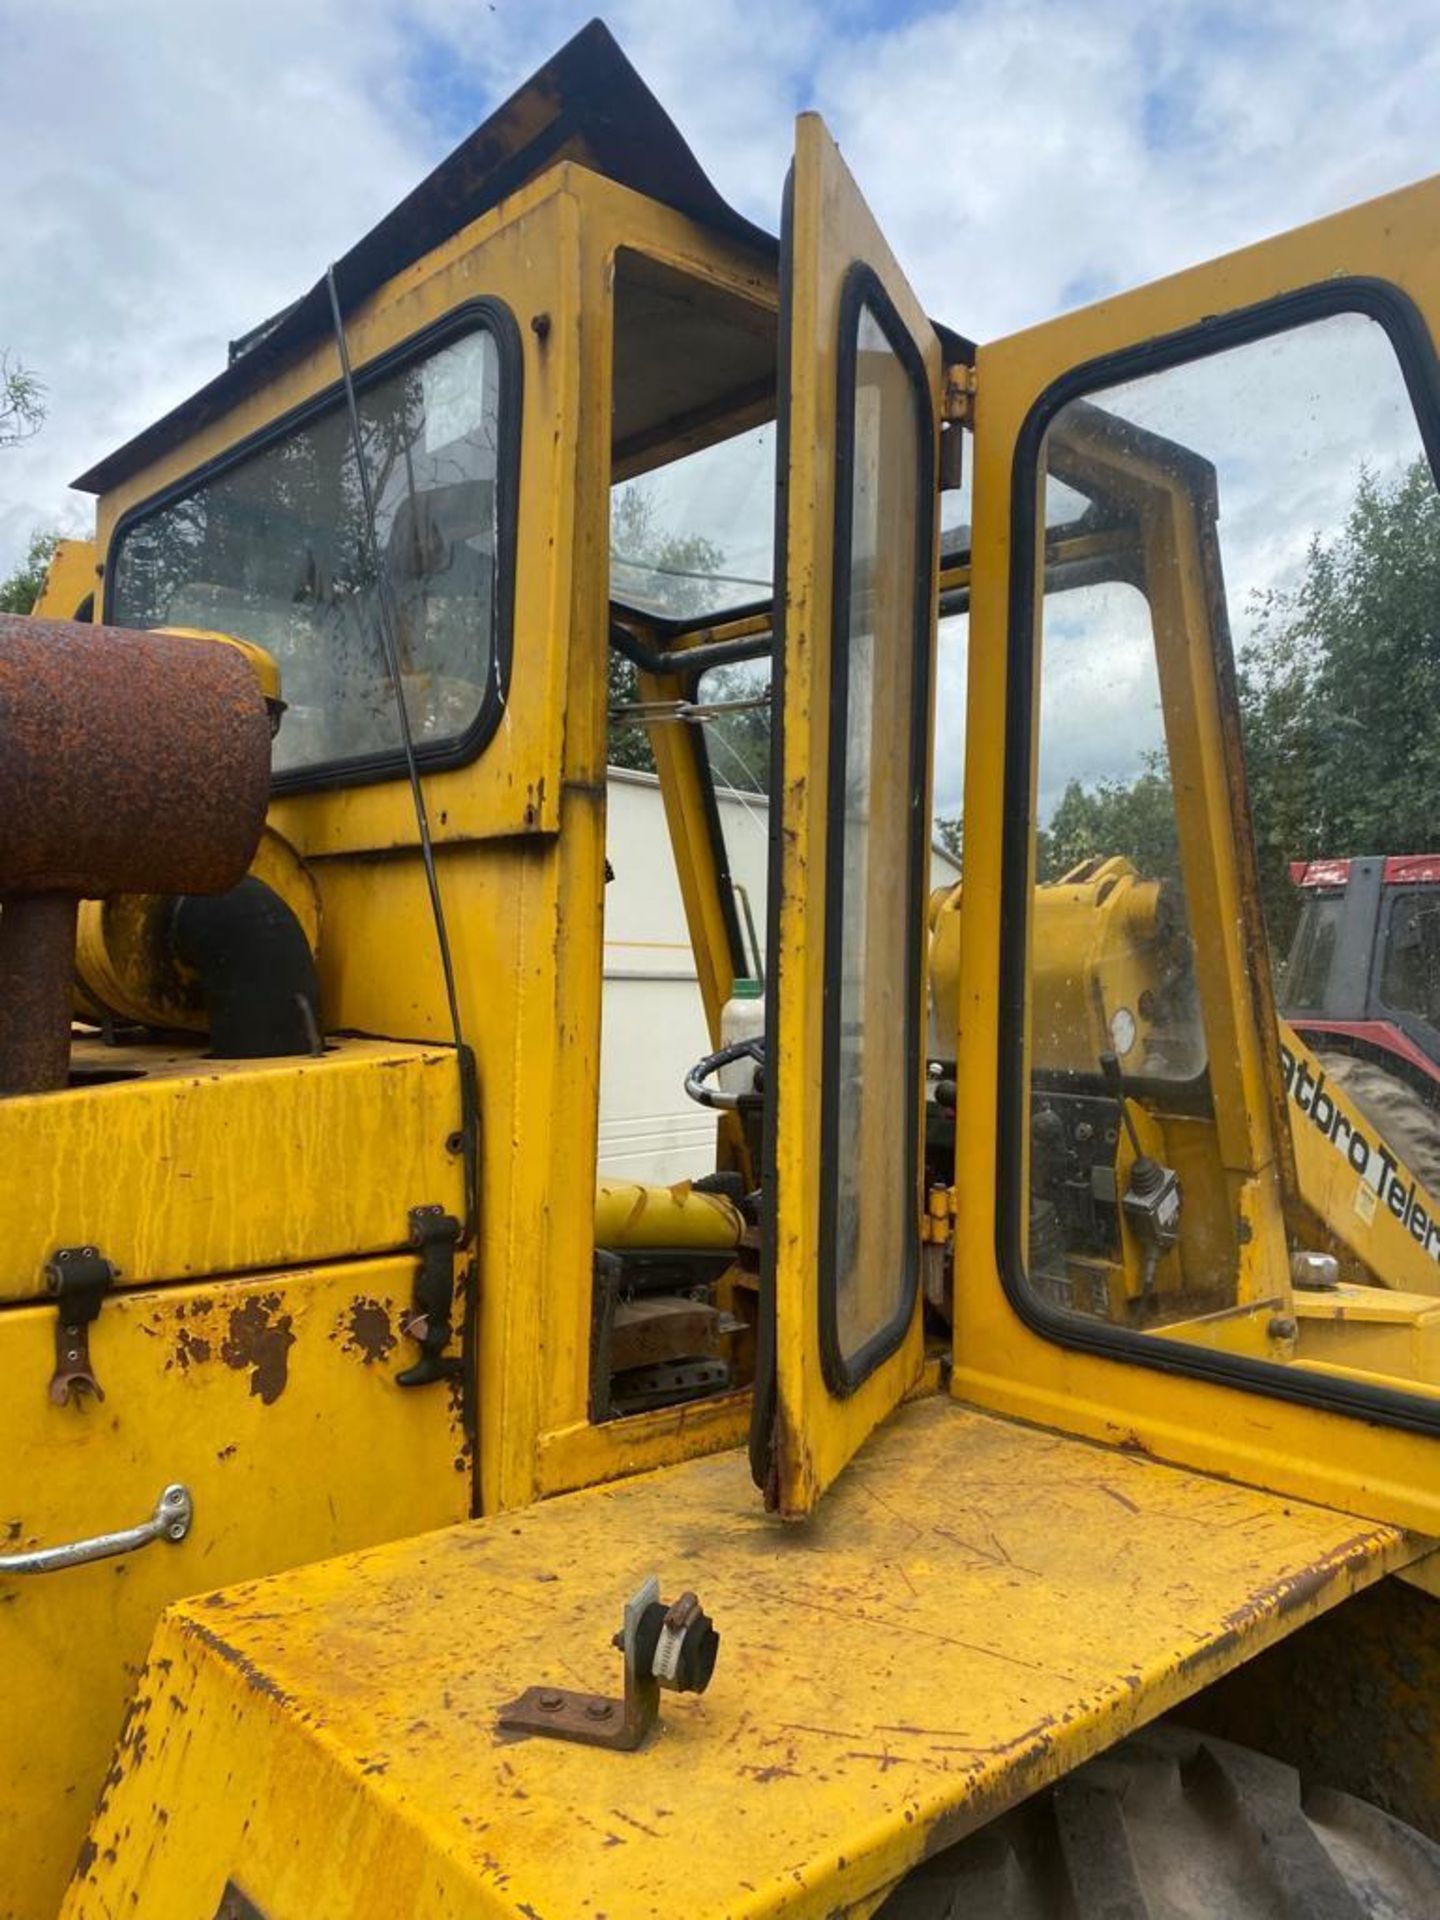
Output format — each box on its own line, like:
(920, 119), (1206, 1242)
(1010, 301), (1440, 1396)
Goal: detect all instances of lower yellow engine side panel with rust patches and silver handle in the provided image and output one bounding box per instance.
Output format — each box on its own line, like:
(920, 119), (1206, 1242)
(0, 1258), (470, 1920)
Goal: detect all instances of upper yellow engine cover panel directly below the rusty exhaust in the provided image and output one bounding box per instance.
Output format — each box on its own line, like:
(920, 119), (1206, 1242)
(0, 1041), (463, 1302)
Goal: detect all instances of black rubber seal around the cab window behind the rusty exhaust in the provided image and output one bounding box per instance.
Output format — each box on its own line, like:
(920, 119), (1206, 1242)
(102, 294), (524, 797)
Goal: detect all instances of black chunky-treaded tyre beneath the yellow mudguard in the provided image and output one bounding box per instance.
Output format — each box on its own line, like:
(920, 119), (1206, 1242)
(876, 1720), (1440, 1920)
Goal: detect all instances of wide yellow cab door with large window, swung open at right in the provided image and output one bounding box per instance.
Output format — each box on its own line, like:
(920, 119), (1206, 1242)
(954, 180), (1440, 1532)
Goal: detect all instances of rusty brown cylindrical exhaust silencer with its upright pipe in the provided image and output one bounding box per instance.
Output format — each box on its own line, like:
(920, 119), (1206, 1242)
(0, 614), (271, 1098)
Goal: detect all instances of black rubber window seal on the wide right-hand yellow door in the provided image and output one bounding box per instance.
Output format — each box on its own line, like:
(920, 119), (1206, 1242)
(995, 275), (1440, 1434)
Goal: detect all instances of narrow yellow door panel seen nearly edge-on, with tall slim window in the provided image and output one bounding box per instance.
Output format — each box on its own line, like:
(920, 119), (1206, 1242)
(751, 113), (941, 1515)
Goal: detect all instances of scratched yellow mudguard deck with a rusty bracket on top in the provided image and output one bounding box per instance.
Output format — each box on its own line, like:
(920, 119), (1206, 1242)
(67, 1398), (1417, 1920)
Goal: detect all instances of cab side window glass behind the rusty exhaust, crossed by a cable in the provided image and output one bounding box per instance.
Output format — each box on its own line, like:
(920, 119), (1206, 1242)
(108, 326), (518, 785)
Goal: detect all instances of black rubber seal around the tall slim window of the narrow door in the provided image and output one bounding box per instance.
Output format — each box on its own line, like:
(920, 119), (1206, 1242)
(821, 261), (937, 1400)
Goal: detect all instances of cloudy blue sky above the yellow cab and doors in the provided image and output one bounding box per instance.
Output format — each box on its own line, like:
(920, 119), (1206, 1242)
(0, 0), (1440, 825)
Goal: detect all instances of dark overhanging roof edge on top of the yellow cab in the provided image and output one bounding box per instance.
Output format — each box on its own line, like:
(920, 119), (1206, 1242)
(71, 19), (778, 493)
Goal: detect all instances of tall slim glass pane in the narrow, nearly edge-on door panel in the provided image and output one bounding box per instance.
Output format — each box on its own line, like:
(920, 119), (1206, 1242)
(822, 282), (933, 1390)
